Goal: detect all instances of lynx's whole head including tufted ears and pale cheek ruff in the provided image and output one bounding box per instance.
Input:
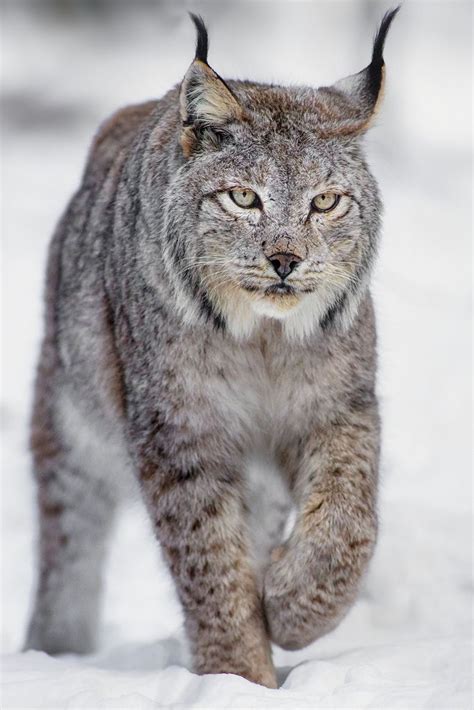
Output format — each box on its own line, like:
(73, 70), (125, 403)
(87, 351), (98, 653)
(161, 9), (398, 337)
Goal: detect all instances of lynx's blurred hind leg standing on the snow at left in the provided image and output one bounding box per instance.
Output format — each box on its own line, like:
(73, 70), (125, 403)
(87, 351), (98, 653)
(25, 392), (120, 654)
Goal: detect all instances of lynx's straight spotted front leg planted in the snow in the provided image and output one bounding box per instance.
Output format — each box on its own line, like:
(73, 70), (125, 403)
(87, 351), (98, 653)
(141, 466), (276, 688)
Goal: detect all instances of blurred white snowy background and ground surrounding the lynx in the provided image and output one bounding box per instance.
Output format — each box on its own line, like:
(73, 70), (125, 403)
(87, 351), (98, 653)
(0, 0), (472, 710)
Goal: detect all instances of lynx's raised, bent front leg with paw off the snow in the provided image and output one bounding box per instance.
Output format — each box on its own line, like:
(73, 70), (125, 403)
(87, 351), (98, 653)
(264, 410), (379, 649)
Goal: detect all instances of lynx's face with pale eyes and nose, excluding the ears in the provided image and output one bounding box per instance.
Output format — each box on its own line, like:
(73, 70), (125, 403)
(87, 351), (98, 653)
(179, 119), (378, 326)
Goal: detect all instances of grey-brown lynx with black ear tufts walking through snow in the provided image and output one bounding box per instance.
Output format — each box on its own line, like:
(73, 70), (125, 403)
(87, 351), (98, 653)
(26, 9), (398, 688)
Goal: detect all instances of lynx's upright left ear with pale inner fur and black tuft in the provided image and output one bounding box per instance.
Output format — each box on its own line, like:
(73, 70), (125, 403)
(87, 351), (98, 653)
(179, 13), (243, 156)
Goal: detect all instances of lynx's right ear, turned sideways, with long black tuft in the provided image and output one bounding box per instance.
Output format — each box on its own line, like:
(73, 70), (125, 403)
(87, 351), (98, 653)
(318, 6), (400, 134)
